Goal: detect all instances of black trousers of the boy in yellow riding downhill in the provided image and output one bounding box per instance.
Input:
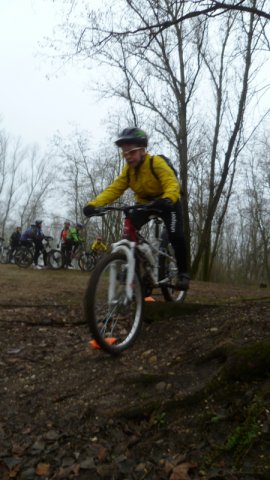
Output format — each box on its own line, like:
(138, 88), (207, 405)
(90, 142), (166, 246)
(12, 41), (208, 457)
(131, 200), (188, 273)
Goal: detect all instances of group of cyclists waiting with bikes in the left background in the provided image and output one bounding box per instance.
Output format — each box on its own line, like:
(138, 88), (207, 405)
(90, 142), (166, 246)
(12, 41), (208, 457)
(5, 220), (108, 269)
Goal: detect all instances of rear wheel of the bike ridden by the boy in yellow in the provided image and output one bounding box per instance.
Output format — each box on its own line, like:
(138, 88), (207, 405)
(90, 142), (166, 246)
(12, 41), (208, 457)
(159, 244), (187, 303)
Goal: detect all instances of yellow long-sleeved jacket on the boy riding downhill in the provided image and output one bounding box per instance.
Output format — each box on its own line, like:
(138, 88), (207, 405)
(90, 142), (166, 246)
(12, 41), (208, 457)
(88, 153), (181, 207)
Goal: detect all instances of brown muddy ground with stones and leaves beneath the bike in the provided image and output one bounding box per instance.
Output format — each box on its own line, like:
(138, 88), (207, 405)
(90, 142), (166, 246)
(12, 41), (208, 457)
(0, 265), (270, 480)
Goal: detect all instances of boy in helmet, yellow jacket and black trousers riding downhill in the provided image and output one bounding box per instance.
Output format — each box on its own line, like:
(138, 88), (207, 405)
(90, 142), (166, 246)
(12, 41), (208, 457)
(83, 127), (190, 290)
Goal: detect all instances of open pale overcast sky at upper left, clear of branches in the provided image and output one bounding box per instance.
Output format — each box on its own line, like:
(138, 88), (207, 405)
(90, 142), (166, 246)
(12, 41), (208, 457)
(0, 0), (102, 146)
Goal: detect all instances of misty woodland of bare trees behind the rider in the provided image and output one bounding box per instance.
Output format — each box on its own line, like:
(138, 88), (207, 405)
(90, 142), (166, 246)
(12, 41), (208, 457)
(0, 0), (270, 283)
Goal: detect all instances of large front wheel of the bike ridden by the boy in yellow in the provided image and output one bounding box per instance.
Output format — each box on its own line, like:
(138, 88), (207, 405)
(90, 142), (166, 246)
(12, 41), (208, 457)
(84, 253), (144, 354)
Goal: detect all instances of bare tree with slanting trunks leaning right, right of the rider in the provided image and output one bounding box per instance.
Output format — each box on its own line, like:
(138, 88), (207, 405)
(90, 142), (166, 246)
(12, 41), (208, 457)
(190, 3), (270, 280)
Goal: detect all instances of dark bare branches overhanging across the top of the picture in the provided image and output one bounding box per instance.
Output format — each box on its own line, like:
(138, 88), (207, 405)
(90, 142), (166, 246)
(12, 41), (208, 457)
(52, 0), (270, 51)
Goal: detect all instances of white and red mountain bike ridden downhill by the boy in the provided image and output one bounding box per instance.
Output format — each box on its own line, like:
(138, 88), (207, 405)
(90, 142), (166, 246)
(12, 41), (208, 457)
(84, 205), (186, 354)
